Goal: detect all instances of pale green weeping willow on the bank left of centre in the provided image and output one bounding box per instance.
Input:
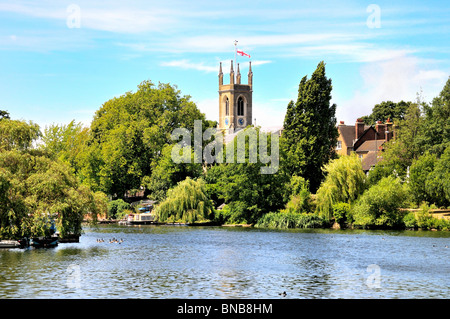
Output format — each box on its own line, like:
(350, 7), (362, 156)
(155, 177), (213, 223)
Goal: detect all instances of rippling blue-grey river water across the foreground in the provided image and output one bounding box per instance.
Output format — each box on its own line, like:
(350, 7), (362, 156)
(0, 225), (450, 299)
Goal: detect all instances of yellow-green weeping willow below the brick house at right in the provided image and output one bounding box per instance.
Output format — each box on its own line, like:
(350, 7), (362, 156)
(316, 153), (366, 220)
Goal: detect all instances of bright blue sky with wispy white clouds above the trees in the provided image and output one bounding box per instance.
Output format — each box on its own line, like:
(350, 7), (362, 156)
(0, 0), (450, 127)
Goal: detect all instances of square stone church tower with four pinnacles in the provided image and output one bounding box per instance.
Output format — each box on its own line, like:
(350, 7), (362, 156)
(217, 61), (253, 135)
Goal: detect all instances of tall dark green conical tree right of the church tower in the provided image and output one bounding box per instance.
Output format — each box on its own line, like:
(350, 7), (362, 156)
(280, 61), (338, 192)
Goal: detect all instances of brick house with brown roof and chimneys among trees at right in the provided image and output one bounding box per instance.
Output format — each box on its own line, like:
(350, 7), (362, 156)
(336, 119), (394, 172)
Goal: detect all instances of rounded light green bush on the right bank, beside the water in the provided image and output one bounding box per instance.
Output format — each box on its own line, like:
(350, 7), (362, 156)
(352, 176), (408, 228)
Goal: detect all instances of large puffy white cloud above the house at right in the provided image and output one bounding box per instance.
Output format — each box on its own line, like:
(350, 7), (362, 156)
(334, 55), (448, 123)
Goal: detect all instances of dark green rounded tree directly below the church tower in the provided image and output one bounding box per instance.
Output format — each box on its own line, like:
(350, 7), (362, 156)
(205, 127), (289, 224)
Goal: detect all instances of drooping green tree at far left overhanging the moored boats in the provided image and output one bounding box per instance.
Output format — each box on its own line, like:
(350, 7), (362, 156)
(0, 150), (106, 239)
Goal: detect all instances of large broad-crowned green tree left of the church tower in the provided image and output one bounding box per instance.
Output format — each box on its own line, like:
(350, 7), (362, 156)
(88, 81), (212, 198)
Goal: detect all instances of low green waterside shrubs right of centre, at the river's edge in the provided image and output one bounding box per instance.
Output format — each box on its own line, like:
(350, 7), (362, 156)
(255, 211), (324, 229)
